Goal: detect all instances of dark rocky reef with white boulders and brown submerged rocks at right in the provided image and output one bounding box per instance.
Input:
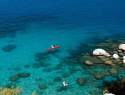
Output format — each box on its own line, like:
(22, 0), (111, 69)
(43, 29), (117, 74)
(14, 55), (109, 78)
(58, 39), (125, 95)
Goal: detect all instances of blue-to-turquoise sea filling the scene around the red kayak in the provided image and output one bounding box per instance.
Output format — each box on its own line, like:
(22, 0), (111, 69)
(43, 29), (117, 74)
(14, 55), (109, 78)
(0, 0), (125, 95)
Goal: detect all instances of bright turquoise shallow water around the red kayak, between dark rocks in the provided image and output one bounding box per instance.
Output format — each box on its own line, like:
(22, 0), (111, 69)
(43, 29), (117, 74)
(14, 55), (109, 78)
(0, 20), (124, 95)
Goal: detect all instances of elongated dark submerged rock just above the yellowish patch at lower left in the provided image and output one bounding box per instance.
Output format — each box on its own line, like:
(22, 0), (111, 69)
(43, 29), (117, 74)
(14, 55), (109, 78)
(10, 72), (30, 82)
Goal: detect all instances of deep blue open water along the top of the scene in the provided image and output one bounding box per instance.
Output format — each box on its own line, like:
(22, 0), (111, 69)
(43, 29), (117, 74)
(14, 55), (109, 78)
(0, 0), (125, 24)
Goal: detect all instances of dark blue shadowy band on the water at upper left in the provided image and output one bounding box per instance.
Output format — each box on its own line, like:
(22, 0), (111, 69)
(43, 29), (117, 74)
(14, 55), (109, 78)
(0, 15), (58, 38)
